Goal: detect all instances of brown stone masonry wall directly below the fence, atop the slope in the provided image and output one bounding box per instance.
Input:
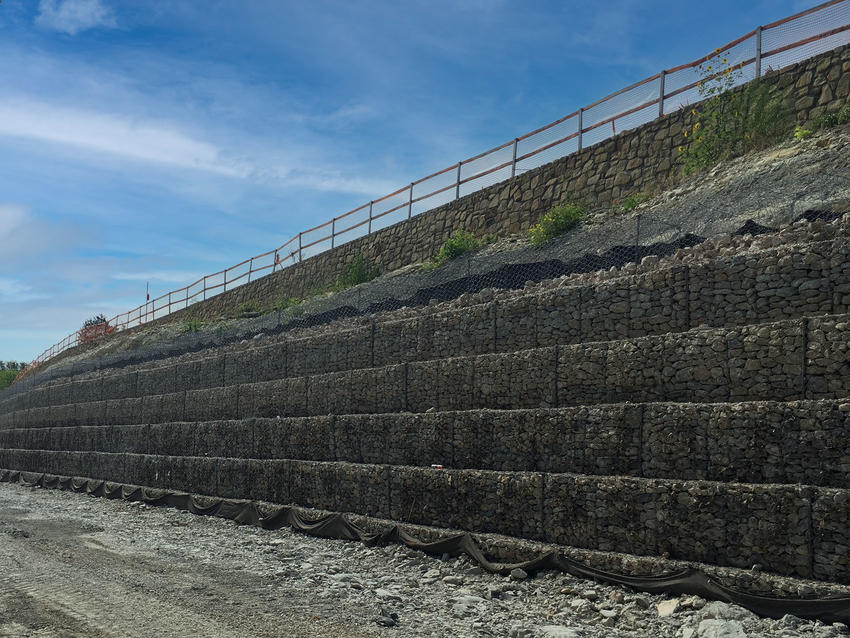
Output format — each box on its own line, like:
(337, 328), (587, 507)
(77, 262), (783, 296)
(151, 46), (850, 321)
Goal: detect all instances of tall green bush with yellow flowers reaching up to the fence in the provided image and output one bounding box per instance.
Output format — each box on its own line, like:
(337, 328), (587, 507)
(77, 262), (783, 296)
(679, 49), (793, 174)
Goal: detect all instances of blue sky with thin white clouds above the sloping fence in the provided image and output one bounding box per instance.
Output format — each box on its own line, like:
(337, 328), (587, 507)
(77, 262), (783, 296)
(0, 0), (814, 360)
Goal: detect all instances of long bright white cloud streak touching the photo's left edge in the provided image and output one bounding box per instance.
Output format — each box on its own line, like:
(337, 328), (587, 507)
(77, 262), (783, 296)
(0, 99), (245, 176)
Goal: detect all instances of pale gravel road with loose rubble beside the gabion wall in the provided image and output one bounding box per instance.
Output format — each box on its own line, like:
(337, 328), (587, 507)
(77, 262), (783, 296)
(0, 483), (847, 638)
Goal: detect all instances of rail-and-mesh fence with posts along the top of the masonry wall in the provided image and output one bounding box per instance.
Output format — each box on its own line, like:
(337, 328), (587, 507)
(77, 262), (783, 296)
(18, 0), (850, 380)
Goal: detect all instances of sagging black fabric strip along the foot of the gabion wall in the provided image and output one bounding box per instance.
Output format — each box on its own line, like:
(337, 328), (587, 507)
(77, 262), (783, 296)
(0, 470), (850, 624)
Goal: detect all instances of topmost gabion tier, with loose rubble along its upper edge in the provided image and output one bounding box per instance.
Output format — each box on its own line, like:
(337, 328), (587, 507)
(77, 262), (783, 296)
(6, 232), (850, 408)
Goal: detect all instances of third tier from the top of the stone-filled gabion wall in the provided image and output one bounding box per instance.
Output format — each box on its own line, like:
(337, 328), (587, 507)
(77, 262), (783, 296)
(0, 400), (850, 488)
